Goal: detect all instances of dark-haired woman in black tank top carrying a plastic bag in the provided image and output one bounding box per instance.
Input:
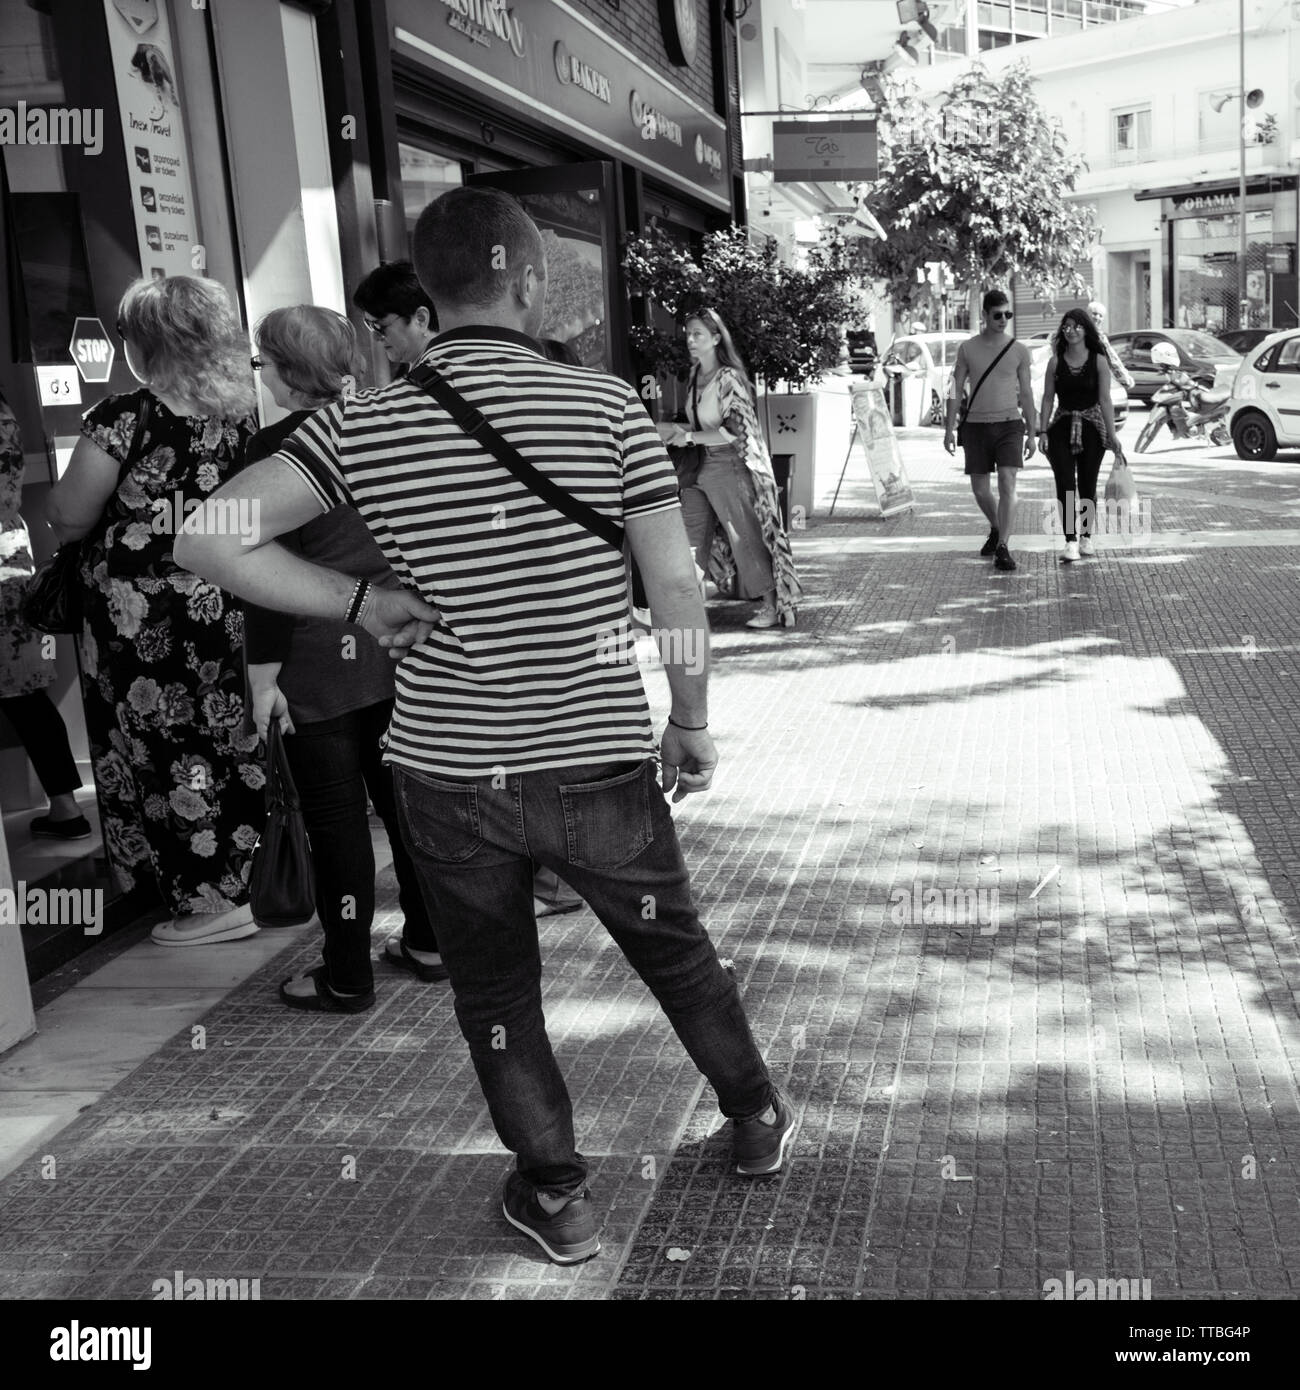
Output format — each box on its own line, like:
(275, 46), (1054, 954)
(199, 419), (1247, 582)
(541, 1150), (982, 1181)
(1039, 309), (1123, 562)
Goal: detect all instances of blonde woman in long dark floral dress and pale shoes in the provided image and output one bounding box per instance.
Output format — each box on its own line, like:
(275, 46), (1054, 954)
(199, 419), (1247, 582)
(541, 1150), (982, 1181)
(49, 275), (266, 945)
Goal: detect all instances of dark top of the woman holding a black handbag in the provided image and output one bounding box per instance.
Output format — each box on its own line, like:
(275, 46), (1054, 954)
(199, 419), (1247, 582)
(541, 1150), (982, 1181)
(245, 410), (398, 724)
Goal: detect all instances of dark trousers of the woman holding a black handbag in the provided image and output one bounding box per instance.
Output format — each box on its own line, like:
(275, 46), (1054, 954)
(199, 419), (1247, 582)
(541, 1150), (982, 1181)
(285, 699), (438, 994)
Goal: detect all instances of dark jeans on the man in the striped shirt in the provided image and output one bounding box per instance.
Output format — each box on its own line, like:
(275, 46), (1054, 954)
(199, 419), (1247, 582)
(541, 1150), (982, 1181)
(393, 762), (773, 1197)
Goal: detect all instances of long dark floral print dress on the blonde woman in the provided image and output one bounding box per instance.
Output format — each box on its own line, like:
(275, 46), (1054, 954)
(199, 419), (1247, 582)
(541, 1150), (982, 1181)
(81, 391), (266, 916)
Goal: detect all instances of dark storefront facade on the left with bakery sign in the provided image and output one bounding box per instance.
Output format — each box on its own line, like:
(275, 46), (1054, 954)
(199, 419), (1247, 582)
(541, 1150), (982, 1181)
(0, 0), (744, 1011)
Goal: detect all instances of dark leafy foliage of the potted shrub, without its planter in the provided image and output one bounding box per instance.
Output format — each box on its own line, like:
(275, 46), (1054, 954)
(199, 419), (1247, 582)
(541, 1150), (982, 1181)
(624, 227), (861, 391)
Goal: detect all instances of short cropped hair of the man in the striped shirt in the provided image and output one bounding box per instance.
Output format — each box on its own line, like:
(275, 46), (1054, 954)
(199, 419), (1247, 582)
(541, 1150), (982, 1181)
(412, 188), (546, 306)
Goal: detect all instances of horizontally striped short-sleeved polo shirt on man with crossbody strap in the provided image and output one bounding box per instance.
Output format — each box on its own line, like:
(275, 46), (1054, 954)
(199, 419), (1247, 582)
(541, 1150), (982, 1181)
(277, 328), (679, 777)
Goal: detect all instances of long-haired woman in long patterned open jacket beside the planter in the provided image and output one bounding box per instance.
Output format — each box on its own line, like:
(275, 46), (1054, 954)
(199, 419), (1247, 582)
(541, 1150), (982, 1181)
(659, 309), (802, 628)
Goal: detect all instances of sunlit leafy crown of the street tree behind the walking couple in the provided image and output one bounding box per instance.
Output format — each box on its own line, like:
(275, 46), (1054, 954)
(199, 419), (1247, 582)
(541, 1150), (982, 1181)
(856, 61), (1097, 321)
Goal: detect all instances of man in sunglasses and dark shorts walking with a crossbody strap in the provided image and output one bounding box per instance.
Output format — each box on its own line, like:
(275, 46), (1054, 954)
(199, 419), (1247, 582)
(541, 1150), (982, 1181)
(944, 289), (1037, 570)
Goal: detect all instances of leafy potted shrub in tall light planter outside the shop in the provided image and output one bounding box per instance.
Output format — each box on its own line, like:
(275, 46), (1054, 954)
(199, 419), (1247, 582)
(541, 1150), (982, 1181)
(624, 225), (862, 516)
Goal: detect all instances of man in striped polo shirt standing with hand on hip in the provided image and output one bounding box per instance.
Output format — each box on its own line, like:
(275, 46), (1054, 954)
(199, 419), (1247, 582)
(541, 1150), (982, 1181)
(177, 188), (793, 1264)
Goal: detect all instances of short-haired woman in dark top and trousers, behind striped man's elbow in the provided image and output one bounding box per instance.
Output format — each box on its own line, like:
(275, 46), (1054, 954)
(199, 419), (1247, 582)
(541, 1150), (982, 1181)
(245, 304), (448, 1013)
